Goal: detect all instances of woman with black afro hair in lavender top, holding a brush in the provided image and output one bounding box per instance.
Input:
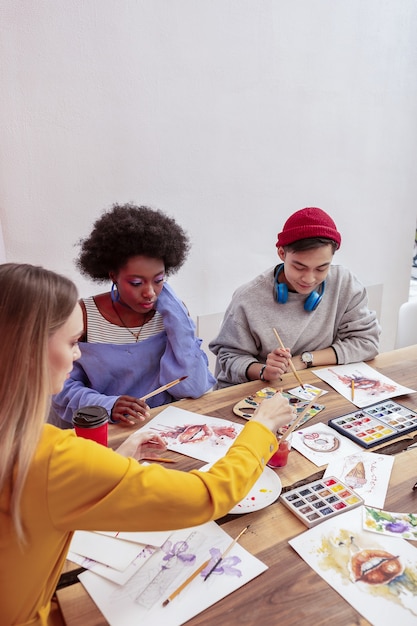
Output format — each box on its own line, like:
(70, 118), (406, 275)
(49, 204), (215, 426)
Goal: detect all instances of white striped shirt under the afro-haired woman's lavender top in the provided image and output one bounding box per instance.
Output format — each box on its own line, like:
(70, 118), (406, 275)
(83, 296), (164, 344)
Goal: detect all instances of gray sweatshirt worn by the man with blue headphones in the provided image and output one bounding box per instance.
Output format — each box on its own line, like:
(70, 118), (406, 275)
(209, 265), (381, 388)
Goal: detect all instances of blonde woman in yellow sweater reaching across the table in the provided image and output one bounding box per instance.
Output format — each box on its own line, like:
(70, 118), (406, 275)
(0, 263), (292, 626)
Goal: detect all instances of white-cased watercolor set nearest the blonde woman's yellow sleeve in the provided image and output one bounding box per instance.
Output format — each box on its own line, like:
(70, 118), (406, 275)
(280, 476), (364, 528)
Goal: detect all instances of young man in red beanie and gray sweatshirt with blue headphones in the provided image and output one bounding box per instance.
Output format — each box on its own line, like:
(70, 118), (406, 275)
(210, 207), (380, 388)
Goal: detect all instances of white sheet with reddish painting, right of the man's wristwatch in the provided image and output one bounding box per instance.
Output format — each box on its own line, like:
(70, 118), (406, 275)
(314, 362), (415, 407)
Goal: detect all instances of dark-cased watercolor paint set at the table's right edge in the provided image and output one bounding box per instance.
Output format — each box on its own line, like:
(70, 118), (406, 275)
(328, 400), (417, 448)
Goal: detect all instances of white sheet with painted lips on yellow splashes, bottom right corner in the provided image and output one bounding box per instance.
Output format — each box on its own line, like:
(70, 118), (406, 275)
(289, 507), (417, 626)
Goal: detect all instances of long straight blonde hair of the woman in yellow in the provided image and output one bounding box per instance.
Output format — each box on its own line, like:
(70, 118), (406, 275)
(0, 263), (78, 542)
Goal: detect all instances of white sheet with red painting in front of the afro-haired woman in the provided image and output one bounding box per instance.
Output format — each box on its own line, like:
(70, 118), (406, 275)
(139, 406), (243, 463)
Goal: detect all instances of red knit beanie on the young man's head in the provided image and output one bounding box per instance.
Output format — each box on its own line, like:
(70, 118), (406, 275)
(276, 207), (342, 248)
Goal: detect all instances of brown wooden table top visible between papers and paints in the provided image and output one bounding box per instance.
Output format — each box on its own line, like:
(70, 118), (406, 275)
(57, 345), (417, 626)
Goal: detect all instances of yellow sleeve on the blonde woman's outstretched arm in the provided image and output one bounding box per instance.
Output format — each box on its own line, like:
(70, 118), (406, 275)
(48, 422), (277, 531)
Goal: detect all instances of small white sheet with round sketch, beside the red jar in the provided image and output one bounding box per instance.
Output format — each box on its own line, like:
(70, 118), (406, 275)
(291, 422), (362, 467)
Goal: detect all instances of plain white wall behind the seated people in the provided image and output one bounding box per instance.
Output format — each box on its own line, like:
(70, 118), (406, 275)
(0, 0), (417, 349)
